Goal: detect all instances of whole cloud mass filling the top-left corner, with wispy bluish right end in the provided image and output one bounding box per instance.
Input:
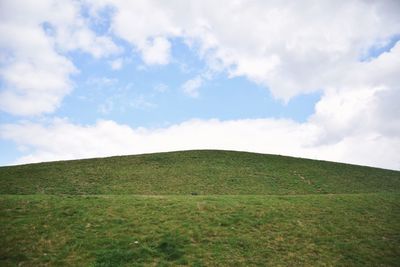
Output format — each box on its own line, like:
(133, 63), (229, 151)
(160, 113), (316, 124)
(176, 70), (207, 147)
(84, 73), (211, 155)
(0, 0), (120, 116)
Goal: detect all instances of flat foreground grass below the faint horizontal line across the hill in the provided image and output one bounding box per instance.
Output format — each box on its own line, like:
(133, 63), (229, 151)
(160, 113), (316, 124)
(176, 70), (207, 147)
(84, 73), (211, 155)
(0, 193), (400, 266)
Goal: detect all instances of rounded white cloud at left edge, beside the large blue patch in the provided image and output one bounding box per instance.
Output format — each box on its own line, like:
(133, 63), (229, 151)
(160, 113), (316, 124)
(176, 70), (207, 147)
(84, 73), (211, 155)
(0, 24), (76, 115)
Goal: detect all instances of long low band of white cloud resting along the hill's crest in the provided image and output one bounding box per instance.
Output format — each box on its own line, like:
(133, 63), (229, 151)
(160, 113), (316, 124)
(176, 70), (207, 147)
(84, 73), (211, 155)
(0, 119), (400, 169)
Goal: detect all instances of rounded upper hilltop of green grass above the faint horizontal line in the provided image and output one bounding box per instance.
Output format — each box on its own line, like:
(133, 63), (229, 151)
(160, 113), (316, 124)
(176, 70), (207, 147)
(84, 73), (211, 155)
(0, 150), (400, 195)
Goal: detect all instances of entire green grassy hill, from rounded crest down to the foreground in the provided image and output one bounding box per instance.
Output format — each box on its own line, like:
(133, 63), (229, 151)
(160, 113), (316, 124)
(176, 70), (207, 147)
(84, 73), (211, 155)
(0, 150), (400, 266)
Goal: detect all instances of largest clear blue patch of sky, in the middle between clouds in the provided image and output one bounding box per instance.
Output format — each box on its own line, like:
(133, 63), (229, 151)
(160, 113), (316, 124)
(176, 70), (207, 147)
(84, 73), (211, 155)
(57, 43), (319, 127)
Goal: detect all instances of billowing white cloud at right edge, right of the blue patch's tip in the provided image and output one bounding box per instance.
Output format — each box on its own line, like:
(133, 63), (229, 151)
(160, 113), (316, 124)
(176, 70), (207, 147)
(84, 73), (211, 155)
(310, 42), (400, 142)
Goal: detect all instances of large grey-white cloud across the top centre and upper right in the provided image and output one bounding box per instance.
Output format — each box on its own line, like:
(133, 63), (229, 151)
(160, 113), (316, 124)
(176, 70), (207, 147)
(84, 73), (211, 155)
(88, 0), (400, 101)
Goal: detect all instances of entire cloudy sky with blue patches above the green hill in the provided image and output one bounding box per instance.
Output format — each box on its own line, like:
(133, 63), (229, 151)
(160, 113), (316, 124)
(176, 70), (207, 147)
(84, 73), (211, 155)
(0, 0), (400, 170)
